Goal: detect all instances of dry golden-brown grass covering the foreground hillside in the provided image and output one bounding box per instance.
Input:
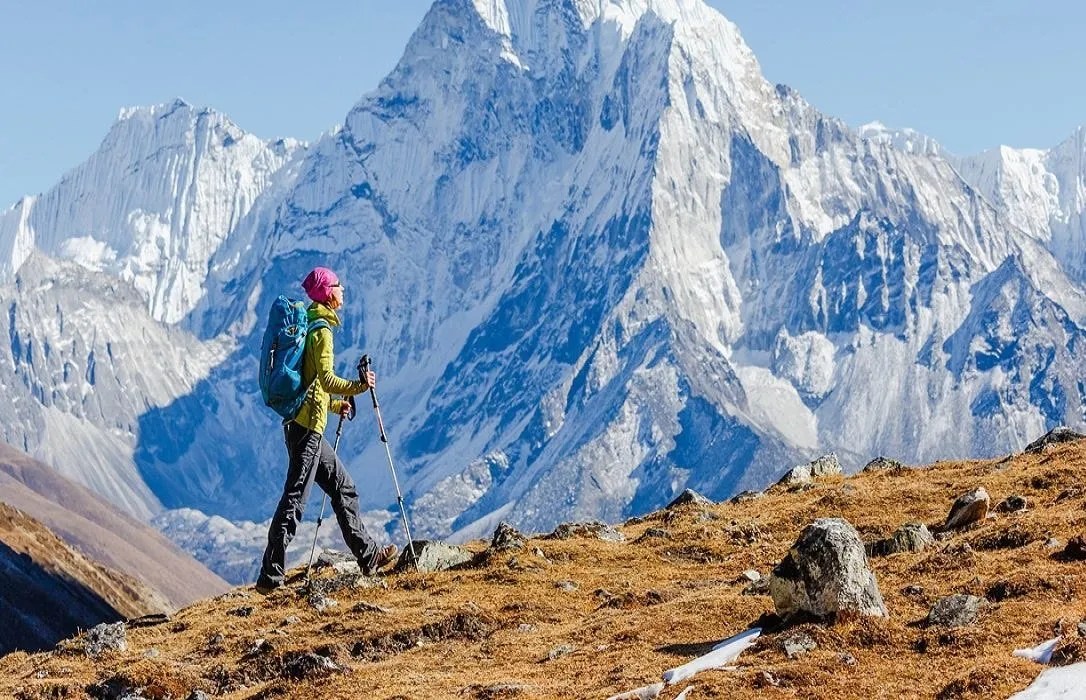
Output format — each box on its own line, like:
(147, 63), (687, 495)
(0, 444), (1086, 700)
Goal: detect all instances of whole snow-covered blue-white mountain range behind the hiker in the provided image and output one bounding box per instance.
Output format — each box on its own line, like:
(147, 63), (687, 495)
(0, 0), (1086, 577)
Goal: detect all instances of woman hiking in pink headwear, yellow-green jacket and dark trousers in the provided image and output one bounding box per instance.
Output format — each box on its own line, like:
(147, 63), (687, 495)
(256, 267), (396, 593)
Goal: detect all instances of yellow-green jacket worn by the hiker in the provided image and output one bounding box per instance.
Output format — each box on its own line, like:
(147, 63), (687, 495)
(294, 302), (369, 433)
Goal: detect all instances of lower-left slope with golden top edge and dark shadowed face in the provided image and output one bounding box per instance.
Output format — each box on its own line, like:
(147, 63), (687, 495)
(0, 504), (166, 652)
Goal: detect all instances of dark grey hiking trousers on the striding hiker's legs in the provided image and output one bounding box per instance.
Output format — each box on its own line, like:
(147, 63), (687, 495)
(256, 421), (377, 586)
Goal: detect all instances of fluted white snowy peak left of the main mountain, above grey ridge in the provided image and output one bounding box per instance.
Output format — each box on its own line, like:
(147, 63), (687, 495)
(0, 100), (303, 322)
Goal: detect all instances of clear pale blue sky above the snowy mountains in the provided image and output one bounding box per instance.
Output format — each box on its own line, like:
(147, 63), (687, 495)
(0, 0), (1086, 208)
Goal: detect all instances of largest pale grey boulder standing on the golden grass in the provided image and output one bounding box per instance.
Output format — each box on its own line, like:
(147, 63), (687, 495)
(769, 518), (887, 618)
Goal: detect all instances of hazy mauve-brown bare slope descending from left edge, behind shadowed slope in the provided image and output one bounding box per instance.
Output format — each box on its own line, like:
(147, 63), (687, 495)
(0, 444), (229, 609)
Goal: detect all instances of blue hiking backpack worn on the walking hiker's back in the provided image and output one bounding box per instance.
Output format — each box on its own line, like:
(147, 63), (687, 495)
(260, 296), (329, 420)
